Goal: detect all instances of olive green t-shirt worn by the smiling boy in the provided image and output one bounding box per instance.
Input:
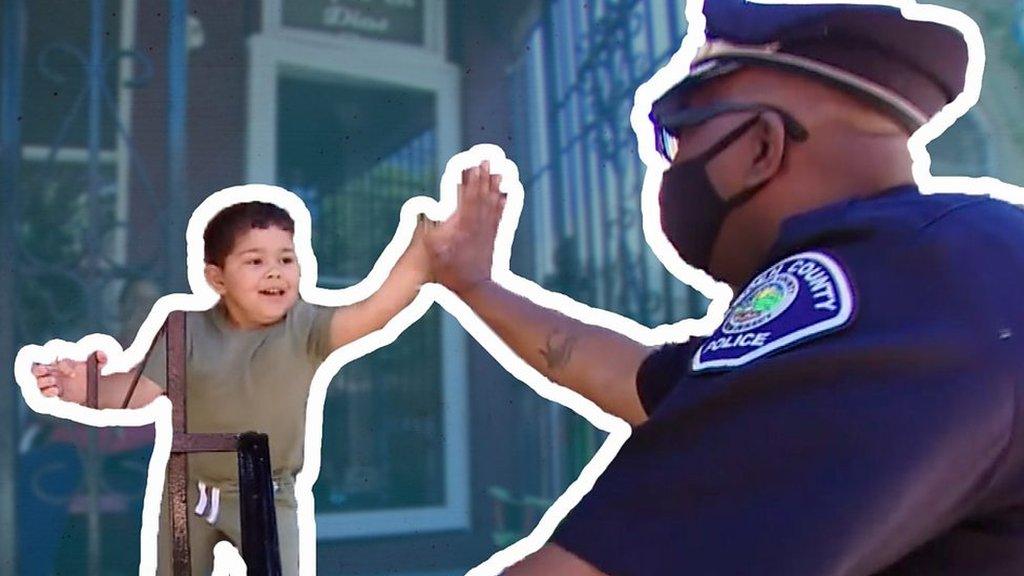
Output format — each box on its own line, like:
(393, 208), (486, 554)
(143, 300), (334, 485)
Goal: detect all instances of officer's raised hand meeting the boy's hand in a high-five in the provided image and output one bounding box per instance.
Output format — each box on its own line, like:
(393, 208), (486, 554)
(425, 161), (505, 294)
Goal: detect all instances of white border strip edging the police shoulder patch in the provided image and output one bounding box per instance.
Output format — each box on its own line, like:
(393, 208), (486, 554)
(693, 250), (854, 372)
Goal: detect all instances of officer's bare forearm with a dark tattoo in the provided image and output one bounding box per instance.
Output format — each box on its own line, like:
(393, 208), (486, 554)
(460, 282), (651, 425)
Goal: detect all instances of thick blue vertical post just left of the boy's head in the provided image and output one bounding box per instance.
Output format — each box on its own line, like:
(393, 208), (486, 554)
(165, 0), (188, 291)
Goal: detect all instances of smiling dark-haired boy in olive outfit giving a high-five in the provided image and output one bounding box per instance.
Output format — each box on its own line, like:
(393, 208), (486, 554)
(33, 196), (429, 575)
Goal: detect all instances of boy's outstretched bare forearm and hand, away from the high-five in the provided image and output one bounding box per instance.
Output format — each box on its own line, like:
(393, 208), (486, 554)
(32, 352), (164, 408)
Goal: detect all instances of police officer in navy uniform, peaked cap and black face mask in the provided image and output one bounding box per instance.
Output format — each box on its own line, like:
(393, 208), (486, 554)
(428, 0), (1024, 576)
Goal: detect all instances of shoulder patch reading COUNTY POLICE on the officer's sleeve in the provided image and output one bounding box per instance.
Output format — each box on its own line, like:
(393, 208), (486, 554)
(691, 251), (856, 372)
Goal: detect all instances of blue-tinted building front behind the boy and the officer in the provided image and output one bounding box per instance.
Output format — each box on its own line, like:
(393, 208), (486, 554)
(0, 0), (1024, 575)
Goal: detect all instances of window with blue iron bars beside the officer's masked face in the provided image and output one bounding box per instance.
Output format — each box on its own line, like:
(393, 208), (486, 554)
(513, 0), (706, 495)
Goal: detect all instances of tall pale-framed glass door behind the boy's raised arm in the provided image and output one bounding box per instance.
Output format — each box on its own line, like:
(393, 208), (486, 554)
(248, 28), (469, 539)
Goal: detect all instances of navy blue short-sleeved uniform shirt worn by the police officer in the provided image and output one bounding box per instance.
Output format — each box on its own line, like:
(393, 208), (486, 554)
(553, 187), (1024, 576)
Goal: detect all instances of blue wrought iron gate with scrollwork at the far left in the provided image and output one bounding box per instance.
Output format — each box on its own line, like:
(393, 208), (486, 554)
(0, 0), (188, 575)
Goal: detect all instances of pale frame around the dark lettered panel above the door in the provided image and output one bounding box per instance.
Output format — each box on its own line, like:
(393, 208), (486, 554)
(262, 0), (447, 57)
